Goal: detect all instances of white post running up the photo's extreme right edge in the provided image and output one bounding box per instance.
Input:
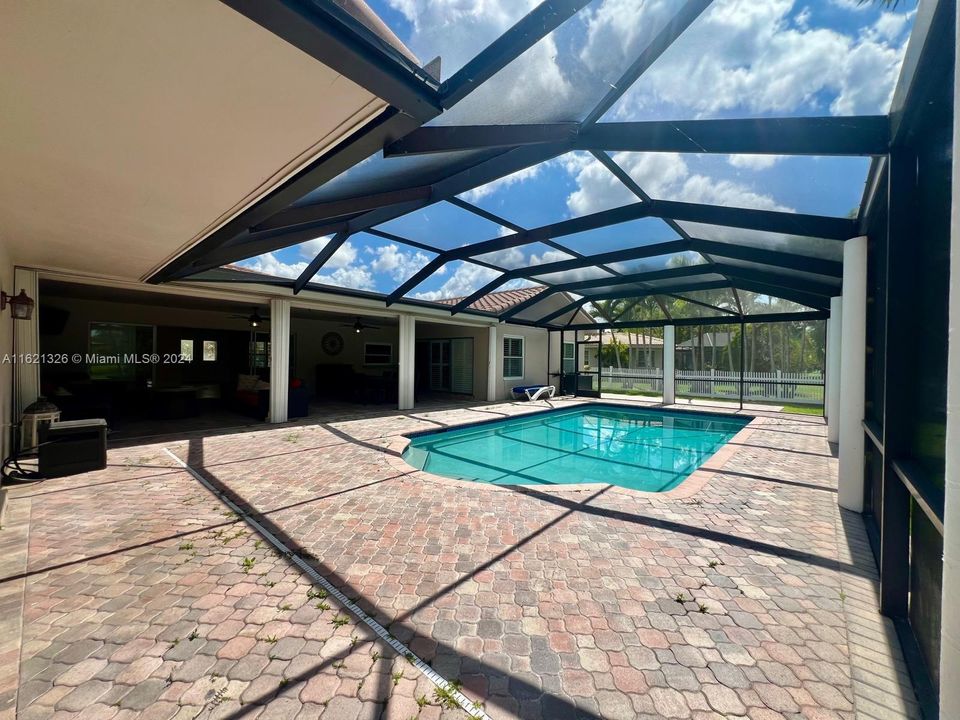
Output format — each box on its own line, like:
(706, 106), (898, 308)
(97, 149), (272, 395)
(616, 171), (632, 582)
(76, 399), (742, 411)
(940, 17), (960, 718)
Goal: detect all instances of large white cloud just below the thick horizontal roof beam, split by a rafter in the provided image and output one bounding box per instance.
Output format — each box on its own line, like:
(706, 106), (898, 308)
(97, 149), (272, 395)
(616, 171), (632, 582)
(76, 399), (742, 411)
(567, 153), (793, 216)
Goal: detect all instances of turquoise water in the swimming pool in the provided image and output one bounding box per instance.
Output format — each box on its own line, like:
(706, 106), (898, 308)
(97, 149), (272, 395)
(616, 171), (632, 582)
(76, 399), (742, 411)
(403, 404), (752, 492)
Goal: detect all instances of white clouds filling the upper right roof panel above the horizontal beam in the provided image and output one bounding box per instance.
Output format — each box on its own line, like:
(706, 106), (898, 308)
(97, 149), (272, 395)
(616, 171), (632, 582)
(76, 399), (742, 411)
(617, 0), (906, 117)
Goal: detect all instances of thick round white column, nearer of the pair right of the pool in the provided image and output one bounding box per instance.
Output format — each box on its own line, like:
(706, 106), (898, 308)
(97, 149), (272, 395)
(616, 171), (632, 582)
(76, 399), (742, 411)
(837, 236), (867, 512)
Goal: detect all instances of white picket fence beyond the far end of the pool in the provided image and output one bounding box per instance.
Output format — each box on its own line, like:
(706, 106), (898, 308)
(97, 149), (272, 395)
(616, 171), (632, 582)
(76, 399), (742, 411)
(601, 367), (824, 405)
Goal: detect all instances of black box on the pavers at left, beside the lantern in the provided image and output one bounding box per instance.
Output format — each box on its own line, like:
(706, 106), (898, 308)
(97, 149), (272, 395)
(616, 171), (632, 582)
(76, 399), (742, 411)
(37, 418), (107, 478)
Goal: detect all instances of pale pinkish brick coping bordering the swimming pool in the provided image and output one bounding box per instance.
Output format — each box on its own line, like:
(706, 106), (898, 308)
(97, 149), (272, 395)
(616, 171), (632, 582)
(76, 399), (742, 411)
(385, 398), (756, 500)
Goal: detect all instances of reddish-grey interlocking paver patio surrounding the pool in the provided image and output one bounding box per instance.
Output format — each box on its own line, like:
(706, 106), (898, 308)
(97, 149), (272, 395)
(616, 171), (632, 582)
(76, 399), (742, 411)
(0, 401), (919, 720)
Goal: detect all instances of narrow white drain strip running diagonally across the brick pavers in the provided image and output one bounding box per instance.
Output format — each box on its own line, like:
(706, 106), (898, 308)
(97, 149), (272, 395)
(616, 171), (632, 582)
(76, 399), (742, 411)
(163, 448), (491, 720)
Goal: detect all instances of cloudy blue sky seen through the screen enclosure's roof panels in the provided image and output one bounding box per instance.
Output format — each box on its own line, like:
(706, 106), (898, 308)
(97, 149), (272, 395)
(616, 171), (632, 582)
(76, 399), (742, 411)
(242, 0), (915, 299)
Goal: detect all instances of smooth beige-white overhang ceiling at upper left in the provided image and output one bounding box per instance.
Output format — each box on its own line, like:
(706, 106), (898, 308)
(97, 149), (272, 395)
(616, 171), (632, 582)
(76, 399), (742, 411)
(0, 0), (385, 279)
